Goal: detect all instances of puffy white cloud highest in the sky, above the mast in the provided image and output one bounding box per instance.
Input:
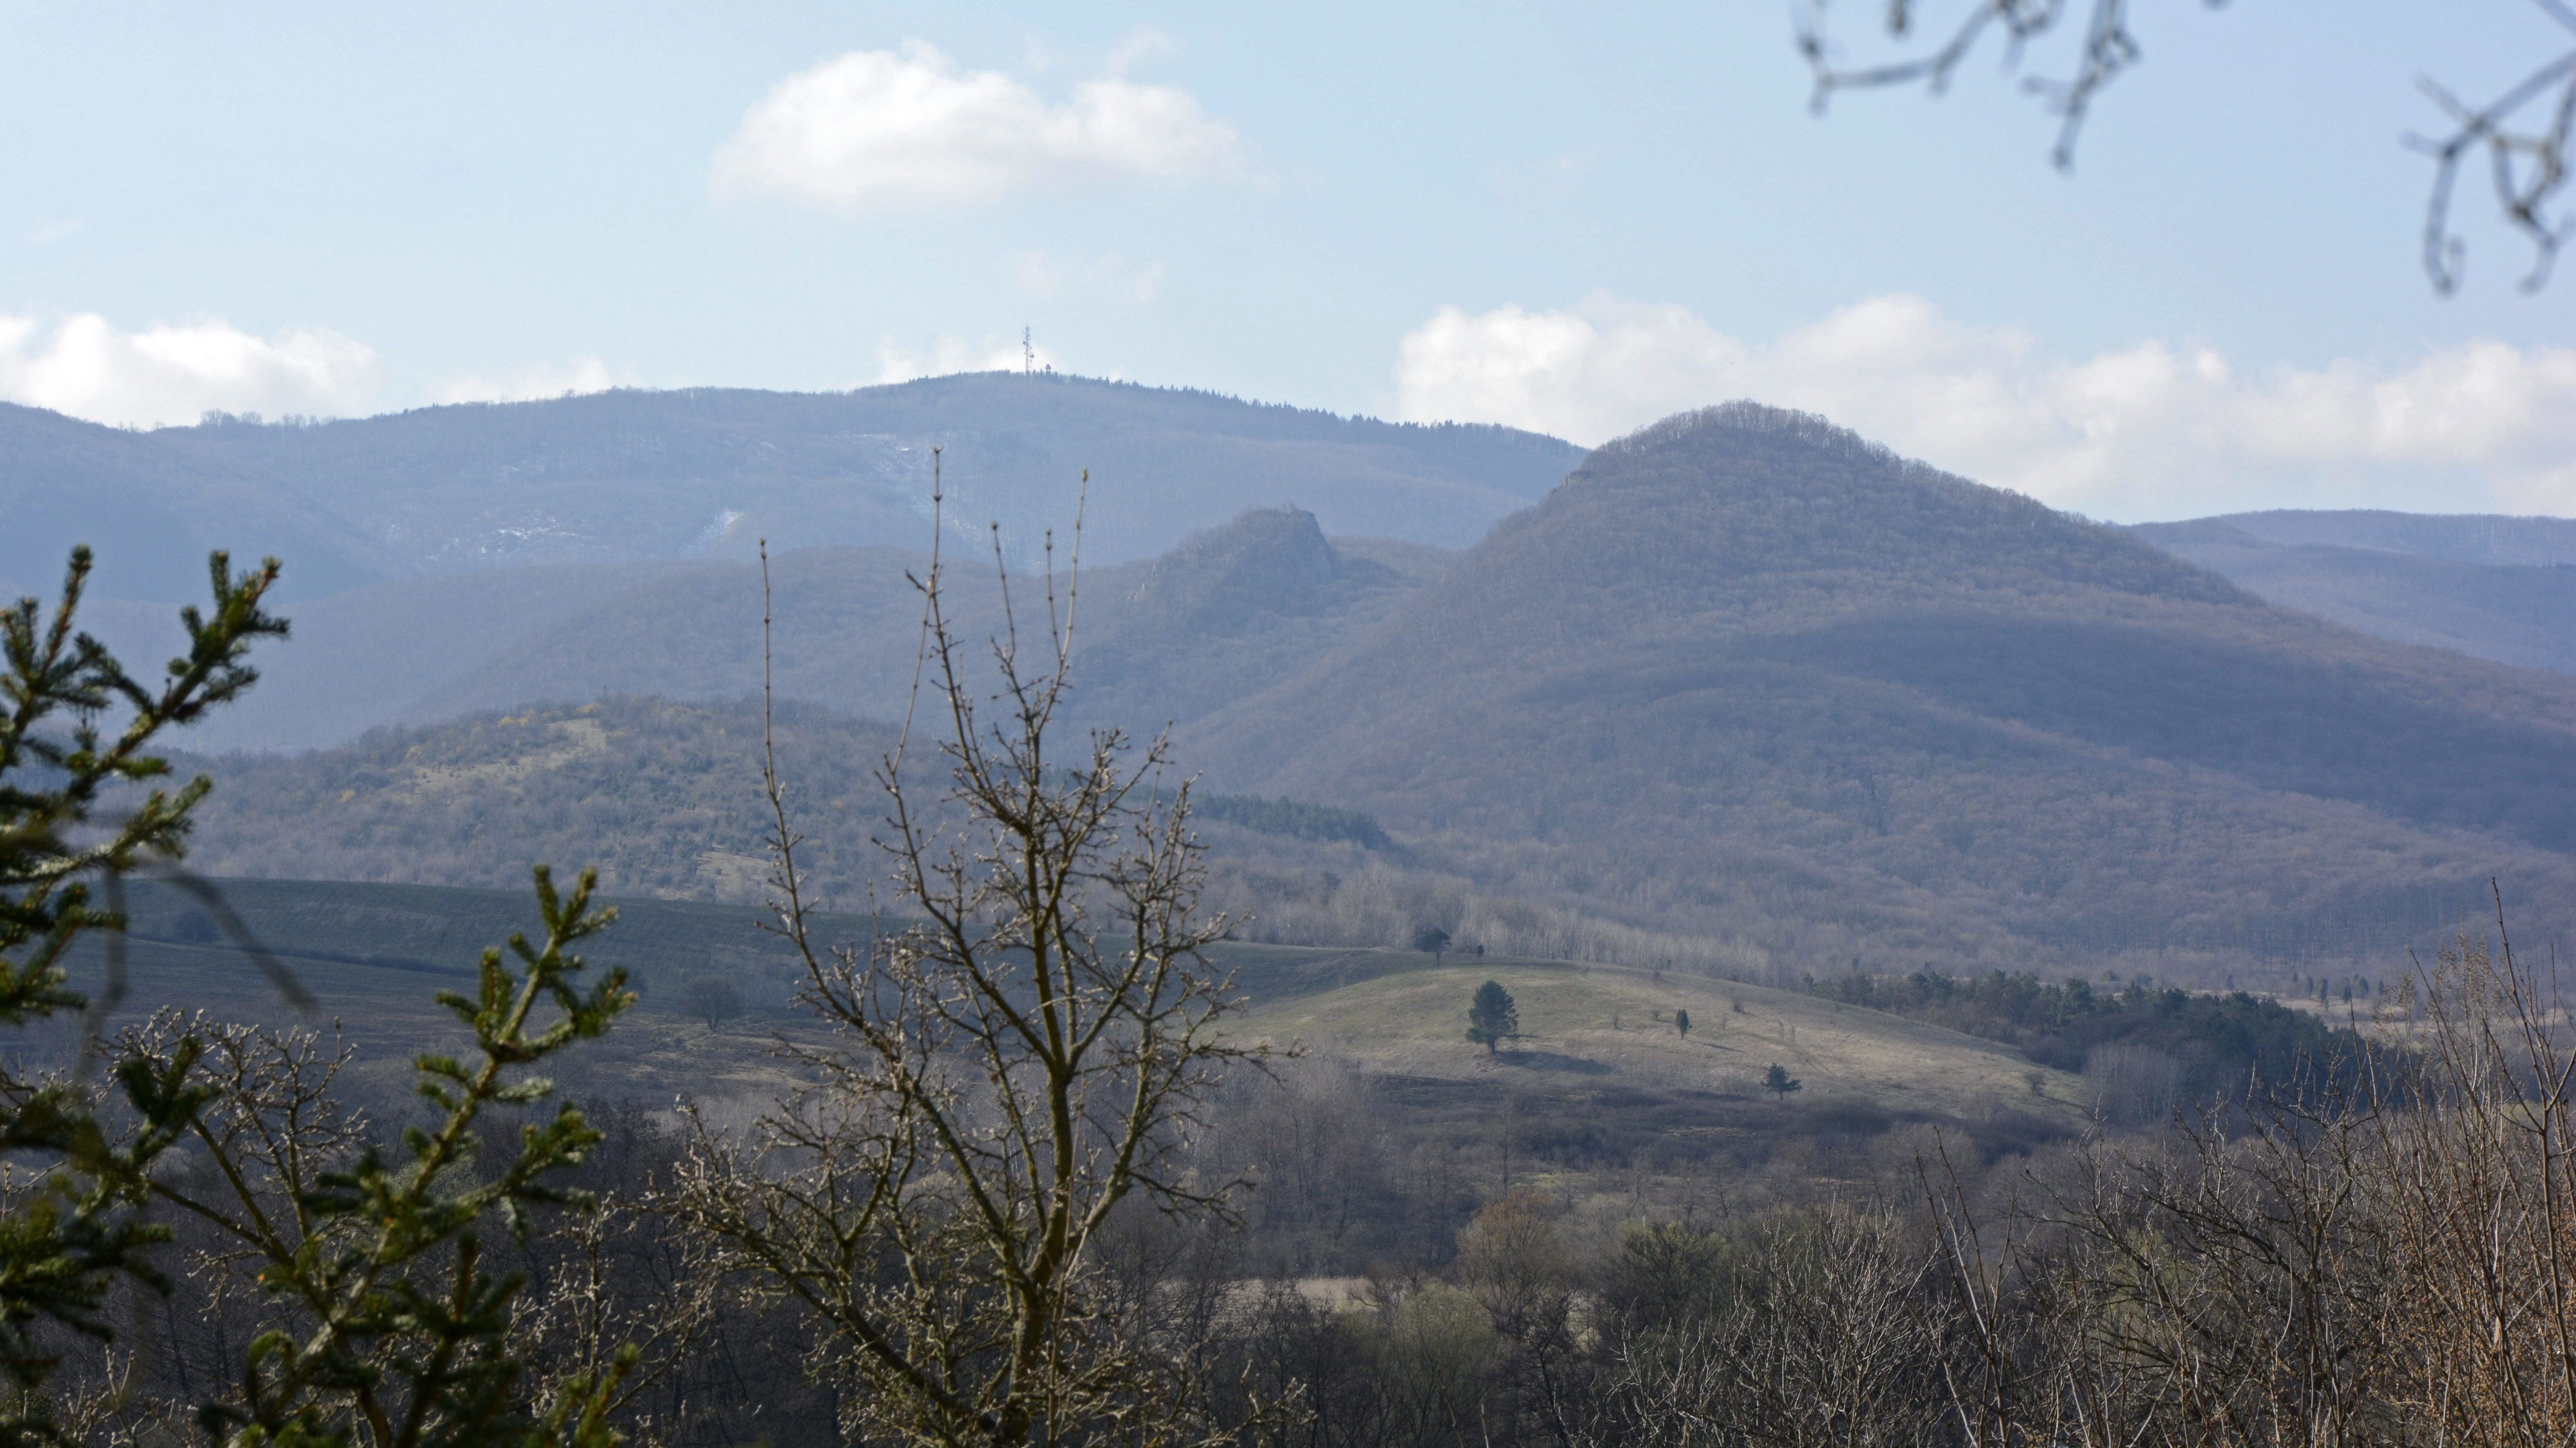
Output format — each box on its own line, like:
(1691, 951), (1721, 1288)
(713, 41), (1244, 211)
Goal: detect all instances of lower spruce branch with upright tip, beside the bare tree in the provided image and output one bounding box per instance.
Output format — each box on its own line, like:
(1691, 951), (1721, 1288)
(175, 866), (634, 1448)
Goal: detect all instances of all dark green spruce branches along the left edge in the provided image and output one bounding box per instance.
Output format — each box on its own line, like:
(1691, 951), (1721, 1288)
(0, 549), (634, 1448)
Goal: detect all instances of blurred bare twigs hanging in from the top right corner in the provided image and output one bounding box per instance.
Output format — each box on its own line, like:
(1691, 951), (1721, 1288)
(1798, 0), (2576, 294)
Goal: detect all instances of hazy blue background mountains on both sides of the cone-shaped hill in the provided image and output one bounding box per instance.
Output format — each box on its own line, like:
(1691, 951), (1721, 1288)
(35, 374), (2576, 750)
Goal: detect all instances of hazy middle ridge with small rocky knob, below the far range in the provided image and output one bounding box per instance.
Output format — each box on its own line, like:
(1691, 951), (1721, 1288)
(169, 508), (1450, 750)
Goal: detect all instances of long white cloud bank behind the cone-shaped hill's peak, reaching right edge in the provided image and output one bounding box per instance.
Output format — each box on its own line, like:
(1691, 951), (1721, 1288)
(1396, 296), (2576, 520)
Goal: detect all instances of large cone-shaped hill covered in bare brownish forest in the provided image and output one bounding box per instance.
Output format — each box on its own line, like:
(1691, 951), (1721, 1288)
(1185, 404), (2576, 974)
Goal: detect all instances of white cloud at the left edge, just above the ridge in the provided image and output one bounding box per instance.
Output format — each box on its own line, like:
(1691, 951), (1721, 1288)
(0, 312), (376, 428)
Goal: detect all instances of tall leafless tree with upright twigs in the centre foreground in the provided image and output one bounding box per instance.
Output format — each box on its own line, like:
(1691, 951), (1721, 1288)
(680, 463), (1265, 1445)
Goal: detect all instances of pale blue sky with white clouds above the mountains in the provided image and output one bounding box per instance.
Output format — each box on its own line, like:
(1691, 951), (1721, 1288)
(0, 0), (2576, 520)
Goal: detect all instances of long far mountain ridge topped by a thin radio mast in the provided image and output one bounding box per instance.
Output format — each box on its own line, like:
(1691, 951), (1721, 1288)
(0, 374), (1582, 600)
